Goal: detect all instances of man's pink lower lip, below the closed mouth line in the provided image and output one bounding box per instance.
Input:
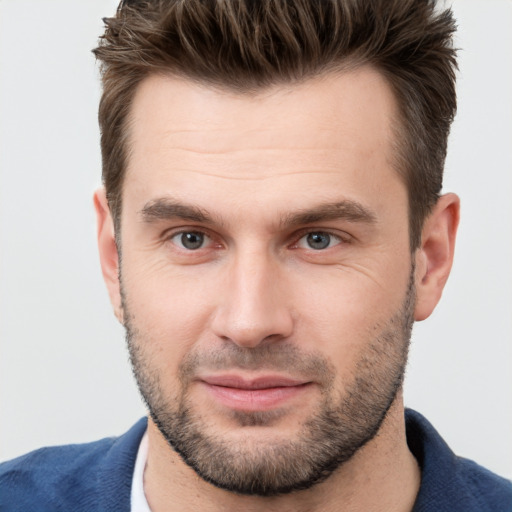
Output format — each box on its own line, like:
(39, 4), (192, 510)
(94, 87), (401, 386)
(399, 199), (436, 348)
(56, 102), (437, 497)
(203, 382), (310, 411)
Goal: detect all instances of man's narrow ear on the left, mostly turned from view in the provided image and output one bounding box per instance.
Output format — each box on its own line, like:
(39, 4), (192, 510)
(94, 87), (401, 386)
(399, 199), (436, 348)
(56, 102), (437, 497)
(94, 188), (123, 323)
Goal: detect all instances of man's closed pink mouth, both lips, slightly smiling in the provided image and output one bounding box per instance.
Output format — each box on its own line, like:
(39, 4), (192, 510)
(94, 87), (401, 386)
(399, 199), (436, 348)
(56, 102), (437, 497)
(199, 375), (313, 412)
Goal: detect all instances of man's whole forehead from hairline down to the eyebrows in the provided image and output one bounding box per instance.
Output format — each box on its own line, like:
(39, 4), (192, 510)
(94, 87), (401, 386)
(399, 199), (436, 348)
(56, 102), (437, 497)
(124, 67), (399, 222)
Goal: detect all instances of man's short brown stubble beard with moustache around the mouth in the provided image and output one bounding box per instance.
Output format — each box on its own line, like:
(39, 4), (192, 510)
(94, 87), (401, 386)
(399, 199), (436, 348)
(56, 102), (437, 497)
(123, 269), (415, 496)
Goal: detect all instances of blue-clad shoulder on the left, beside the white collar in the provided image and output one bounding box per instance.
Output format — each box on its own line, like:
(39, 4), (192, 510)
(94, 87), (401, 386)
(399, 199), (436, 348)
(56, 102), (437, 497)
(0, 419), (146, 512)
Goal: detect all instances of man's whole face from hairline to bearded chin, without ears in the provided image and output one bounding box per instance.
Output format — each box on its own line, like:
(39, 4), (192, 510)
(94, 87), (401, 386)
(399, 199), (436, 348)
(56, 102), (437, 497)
(114, 68), (414, 495)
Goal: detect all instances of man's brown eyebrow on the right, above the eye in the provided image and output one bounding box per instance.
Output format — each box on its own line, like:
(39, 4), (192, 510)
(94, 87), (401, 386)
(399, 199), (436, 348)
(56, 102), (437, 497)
(281, 199), (377, 226)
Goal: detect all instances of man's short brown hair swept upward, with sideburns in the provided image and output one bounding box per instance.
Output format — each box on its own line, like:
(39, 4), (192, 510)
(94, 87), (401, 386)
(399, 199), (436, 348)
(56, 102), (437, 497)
(94, 0), (456, 249)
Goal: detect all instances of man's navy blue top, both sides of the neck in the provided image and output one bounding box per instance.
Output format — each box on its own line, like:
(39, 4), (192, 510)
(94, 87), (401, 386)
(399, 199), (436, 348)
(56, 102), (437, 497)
(0, 410), (512, 512)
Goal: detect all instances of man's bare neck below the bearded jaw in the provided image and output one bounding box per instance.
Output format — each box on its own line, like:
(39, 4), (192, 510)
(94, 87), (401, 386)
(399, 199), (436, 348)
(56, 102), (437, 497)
(144, 395), (421, 512)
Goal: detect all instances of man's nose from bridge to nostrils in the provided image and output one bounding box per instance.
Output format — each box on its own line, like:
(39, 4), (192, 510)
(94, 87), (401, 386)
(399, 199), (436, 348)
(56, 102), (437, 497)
(212, 252), (293, 348)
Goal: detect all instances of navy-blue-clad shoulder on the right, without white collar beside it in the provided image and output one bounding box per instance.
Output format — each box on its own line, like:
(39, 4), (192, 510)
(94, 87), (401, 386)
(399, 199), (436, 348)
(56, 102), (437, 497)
(406, 410), (512, 512)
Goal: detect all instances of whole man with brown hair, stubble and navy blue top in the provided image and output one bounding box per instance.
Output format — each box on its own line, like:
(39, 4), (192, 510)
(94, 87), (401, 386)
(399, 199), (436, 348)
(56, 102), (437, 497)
(0, 0), (512, 512)
